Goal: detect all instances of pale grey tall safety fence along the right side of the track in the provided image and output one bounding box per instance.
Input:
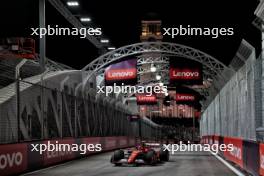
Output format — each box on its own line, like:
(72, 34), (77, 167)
(200, 44), (264, 142)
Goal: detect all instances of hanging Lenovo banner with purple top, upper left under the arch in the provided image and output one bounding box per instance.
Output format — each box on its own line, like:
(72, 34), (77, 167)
(105, 59), (137, 86)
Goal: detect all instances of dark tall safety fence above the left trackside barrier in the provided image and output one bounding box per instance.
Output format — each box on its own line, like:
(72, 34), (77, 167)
(0, 80), (161, 143)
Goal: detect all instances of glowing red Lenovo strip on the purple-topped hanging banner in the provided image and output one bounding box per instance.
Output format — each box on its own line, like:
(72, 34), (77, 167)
(105, 68), (137, 80)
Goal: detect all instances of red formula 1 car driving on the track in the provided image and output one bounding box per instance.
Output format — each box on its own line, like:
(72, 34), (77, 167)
(111, 143), (169, 166)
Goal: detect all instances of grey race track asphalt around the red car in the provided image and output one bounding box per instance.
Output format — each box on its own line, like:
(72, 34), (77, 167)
(23, 152), (235, 176)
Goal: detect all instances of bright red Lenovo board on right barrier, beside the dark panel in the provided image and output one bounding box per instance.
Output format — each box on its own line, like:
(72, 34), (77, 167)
(224, 137), (243, 168)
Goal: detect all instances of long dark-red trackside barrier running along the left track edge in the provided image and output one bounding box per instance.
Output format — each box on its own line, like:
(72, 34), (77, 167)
(0, 136), (136, 176)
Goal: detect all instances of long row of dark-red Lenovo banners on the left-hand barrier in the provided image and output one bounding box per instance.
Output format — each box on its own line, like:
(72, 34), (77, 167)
(0, 136), (136, 176)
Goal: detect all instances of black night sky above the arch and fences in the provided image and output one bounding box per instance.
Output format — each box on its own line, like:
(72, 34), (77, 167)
(0, 0), (261, 69)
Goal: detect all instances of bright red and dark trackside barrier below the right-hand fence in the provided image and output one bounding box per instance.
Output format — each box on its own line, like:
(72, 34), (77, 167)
(201, 135), (264, 176)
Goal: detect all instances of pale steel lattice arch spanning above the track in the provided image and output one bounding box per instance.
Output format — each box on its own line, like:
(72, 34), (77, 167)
(82, 42), (233, 97)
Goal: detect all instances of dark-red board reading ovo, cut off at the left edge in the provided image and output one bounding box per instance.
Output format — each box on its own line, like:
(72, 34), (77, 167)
(0, 143), (28, 175)
